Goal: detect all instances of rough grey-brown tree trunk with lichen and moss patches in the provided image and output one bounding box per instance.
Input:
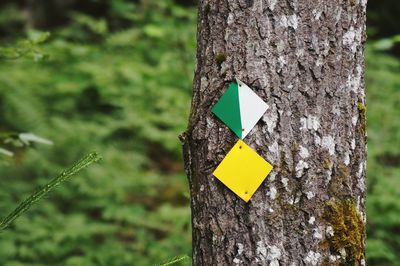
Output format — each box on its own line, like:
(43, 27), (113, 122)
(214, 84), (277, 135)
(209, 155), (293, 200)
(182, 0), (366, 265)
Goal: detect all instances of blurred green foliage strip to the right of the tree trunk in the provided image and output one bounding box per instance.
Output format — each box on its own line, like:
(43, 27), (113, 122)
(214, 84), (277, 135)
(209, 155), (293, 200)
(366, 38), (400, 265)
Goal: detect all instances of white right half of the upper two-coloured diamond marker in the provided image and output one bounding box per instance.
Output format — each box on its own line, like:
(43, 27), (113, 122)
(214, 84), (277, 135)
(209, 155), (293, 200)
(237, 79), (268, 139)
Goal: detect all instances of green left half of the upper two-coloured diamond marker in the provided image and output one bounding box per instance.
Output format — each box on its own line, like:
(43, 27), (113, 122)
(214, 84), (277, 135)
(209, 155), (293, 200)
(211, 82), (242, 139)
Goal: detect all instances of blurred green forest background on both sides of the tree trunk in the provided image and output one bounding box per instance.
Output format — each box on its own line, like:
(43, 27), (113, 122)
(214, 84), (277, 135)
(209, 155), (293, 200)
(0, 0), (400, 266)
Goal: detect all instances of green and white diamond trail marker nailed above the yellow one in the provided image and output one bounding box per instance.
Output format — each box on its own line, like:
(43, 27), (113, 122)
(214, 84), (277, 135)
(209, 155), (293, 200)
(211, 79), (268, 139)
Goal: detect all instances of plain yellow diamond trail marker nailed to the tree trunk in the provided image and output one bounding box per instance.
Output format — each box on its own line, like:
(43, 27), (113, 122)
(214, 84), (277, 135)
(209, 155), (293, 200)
(213, 140), (272, 202)
